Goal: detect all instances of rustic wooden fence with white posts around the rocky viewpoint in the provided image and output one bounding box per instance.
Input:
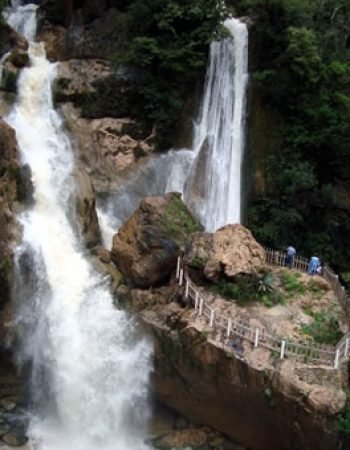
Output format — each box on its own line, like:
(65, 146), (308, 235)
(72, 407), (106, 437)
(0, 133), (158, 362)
(176, 253), (350, 369)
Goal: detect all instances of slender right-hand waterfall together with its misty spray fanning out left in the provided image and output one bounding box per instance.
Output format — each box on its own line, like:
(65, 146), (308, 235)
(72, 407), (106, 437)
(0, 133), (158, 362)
(101, 19), (248, 236)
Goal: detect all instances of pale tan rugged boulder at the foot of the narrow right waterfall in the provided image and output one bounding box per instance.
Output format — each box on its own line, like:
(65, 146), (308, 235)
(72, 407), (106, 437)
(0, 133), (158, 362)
(187, 224), (265, 281)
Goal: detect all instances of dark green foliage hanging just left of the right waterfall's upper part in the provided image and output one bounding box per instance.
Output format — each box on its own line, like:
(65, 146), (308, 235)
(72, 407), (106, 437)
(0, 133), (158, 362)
(116, 0), (226, 148)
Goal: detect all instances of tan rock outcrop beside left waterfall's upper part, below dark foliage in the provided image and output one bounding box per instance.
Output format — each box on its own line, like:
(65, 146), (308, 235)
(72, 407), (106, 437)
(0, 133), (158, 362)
(62, 104), (154, 192)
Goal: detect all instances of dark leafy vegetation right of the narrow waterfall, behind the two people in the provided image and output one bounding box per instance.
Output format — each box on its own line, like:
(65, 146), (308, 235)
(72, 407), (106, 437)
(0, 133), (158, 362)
(234, 0), (350, 271)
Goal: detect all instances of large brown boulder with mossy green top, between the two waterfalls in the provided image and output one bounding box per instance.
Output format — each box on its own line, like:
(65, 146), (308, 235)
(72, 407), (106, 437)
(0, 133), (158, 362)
(111, 193), (201, 288)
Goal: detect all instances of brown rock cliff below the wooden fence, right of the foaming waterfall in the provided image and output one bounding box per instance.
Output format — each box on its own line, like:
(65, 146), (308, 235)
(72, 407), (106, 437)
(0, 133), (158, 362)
(131, 286), (345, 450)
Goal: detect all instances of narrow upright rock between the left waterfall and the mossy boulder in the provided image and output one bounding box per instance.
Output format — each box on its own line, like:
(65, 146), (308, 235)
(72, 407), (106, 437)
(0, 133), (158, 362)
(74, 168), (101, 247)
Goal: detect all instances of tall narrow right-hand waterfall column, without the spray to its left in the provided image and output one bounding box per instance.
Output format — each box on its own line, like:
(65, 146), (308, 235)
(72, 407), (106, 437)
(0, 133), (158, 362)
(184, 19), (248, 231)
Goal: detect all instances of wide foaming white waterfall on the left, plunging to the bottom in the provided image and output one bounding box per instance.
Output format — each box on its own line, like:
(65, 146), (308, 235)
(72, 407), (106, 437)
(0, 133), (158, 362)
(7, 5), (152, 450)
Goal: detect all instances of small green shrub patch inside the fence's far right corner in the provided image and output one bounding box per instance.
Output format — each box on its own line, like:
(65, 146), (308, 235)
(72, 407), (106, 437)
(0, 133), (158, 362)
(302, 309), (343, 345)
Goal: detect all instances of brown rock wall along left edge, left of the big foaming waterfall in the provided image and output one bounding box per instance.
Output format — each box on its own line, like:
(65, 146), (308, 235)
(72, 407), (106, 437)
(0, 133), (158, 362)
(0, 119), (25, 445)
